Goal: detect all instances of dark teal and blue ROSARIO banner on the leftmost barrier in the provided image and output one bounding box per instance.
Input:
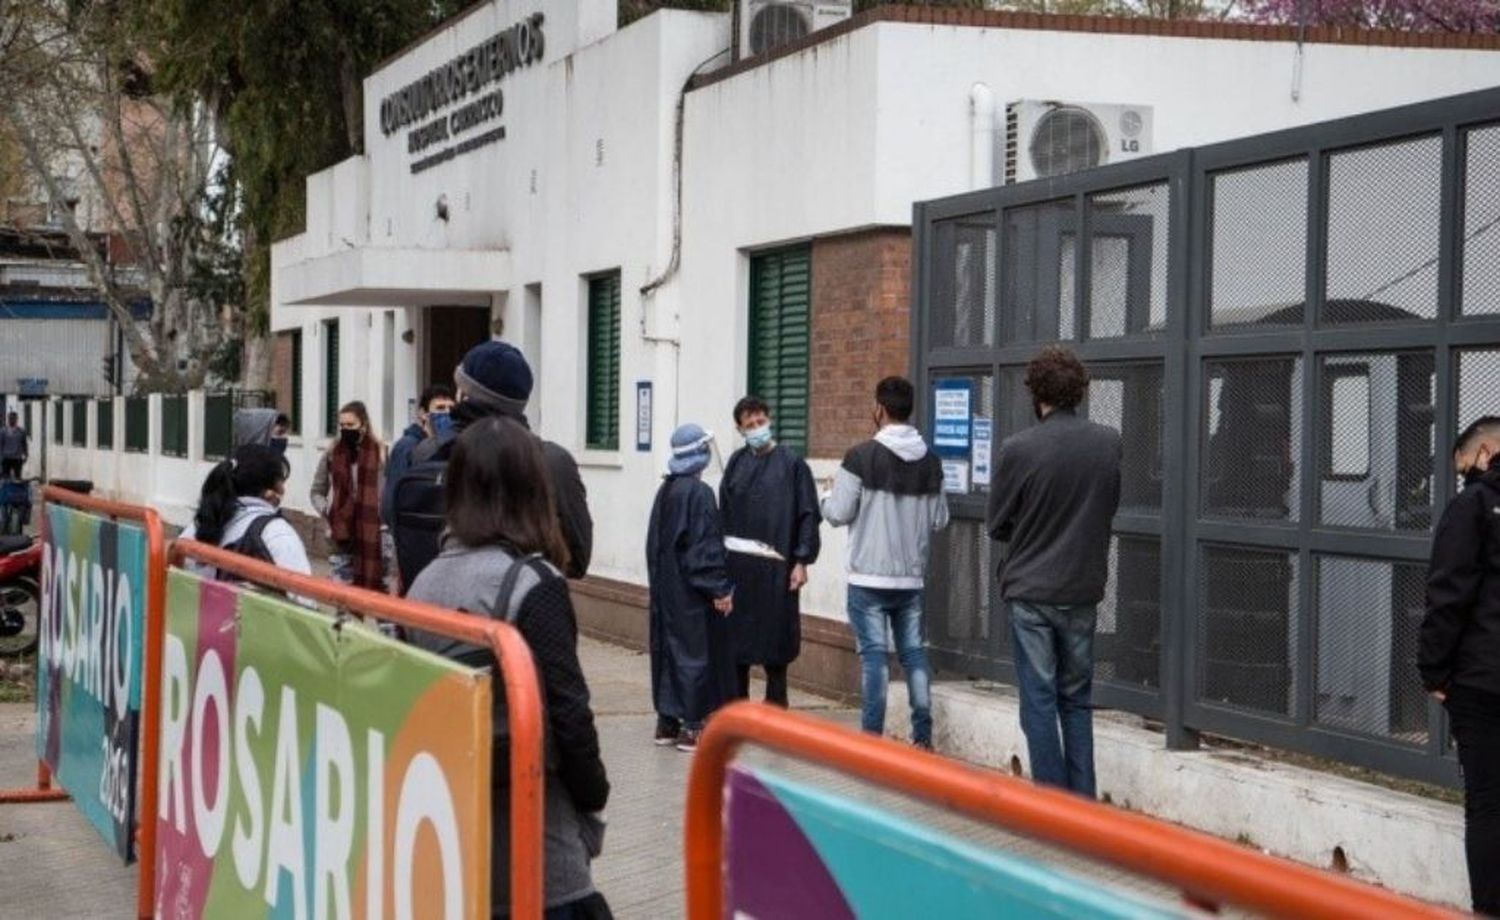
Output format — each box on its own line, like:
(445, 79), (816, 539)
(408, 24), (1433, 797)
(36, 503), (147, 861)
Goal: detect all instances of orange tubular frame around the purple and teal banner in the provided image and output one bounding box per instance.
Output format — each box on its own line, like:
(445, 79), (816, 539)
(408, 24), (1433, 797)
(683, 702), (1460, 920)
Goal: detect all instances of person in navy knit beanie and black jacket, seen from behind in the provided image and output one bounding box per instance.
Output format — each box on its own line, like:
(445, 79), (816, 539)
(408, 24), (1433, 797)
(411, 341), (594, 578)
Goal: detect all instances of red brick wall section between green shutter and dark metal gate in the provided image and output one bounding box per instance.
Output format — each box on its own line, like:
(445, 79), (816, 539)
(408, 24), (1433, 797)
(809, 228), (912, 459)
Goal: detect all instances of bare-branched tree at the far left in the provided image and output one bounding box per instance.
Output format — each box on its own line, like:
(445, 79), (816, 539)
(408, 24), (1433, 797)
(0, 0), (240, 390)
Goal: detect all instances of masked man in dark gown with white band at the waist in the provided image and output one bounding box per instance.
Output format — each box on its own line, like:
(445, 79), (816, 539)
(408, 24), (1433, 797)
(719, 396), (822, 708)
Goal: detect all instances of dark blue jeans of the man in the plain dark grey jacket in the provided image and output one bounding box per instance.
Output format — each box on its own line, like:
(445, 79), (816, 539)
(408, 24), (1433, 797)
(1008, 600), (1098, 798)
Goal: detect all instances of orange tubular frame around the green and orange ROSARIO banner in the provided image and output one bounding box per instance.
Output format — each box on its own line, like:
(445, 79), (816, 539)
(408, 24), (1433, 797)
(171, 540), (543, 920)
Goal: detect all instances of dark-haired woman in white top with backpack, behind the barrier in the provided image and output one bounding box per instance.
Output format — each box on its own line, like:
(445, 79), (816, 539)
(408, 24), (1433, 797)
(182, 444), (312, 576)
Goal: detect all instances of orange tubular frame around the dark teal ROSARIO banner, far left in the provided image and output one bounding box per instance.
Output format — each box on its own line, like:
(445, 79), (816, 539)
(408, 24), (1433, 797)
(0, 486), (167, 920)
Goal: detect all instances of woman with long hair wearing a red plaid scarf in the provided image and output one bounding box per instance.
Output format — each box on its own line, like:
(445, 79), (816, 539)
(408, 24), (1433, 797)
(312, 401), (386, 591)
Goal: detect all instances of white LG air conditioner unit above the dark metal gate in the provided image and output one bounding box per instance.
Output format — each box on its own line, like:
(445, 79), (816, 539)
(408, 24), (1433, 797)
(995, 99), (1152, 185)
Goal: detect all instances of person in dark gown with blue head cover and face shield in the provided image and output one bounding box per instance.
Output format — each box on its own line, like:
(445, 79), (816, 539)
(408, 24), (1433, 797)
(647, 425), (735, 752)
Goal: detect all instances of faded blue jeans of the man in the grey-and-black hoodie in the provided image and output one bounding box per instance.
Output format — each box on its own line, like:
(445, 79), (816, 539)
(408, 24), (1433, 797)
(849, 585), (933, 744)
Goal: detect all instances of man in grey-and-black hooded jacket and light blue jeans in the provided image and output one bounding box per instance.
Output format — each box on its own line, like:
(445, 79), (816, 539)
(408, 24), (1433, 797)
(822, 377), (948, 749)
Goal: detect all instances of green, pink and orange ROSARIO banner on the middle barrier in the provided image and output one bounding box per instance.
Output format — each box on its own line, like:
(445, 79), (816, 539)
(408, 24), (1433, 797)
(156, 569), (491, 920)
